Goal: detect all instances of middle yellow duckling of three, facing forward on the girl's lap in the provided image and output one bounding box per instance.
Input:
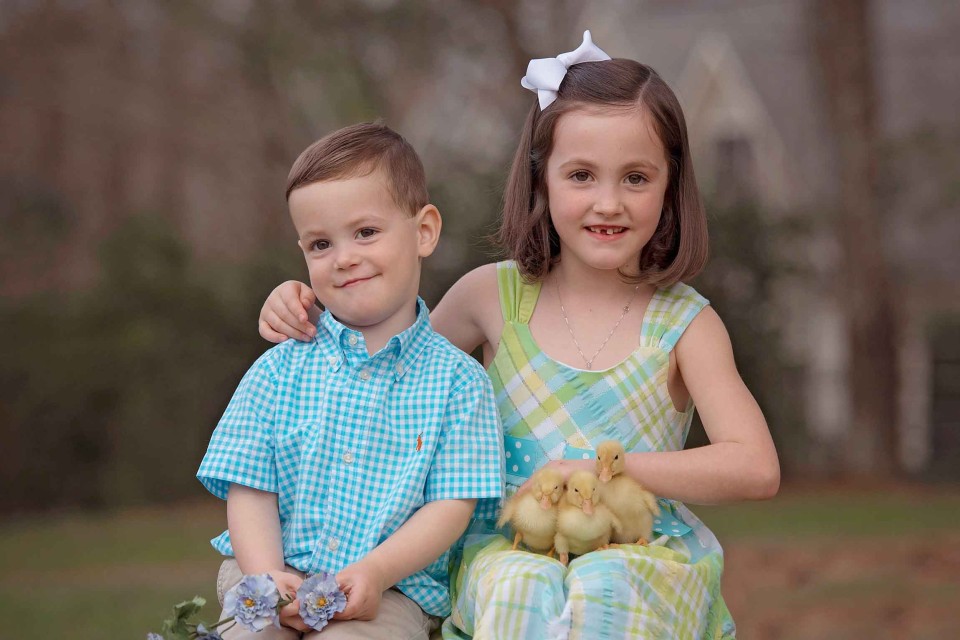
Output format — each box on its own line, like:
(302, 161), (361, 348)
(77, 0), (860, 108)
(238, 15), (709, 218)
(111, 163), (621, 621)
(554, 471), (620, 565)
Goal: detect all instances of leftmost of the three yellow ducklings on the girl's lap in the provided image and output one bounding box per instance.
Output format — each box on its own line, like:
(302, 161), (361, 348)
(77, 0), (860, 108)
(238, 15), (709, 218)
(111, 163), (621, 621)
(497, 467), (563, 551)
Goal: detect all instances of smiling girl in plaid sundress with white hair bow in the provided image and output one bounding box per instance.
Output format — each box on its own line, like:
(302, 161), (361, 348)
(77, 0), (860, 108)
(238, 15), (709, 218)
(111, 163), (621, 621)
(260, 32), (780, 639)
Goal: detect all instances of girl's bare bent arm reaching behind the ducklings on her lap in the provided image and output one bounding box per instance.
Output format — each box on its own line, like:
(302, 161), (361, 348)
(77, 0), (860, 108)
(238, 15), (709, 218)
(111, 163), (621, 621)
(627, 306), (780, 504)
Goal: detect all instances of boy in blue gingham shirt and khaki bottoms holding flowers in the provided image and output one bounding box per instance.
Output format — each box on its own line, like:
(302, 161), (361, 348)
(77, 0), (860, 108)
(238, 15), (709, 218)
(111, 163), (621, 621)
(197, 124), (503, 640)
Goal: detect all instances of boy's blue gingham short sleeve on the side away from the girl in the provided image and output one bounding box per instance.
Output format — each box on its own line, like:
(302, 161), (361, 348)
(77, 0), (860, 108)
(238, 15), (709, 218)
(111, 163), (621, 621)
(197, 350), (277, 500)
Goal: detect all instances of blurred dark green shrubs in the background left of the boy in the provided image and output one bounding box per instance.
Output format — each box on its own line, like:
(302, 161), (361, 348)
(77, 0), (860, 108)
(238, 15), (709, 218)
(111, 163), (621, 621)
(0, 216), (296, 511)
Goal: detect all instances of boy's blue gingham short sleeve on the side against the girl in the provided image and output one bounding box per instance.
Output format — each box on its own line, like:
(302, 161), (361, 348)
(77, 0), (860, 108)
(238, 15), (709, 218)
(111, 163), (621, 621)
(424, 365), (503, 510)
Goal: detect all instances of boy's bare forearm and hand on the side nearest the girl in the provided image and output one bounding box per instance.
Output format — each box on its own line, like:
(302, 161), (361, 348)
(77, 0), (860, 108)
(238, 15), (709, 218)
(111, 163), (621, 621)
(335, 499), (477, 620)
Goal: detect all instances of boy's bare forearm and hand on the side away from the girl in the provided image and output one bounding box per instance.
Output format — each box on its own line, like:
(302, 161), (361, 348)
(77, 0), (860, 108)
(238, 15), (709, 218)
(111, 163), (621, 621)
(227, 484), (308, 631)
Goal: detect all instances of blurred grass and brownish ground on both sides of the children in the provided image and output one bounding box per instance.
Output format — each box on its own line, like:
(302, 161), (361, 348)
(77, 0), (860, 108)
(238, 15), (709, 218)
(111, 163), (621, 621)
(0, 488), (960, 640)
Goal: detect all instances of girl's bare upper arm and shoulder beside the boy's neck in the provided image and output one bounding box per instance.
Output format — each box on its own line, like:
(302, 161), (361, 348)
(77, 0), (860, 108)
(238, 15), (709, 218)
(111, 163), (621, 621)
(430, 264), (503, 356)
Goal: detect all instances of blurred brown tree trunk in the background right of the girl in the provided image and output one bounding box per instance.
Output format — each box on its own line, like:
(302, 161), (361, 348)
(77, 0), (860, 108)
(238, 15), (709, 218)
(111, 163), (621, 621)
(811, 0), (898, 478)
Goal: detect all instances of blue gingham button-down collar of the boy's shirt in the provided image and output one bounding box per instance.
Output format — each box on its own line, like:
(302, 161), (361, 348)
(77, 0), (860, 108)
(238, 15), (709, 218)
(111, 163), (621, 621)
(314, 296), (433, 380)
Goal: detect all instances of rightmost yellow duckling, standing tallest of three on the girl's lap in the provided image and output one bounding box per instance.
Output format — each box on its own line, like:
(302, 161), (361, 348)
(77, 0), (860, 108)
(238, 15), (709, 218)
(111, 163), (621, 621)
(597, 440), (660, 545)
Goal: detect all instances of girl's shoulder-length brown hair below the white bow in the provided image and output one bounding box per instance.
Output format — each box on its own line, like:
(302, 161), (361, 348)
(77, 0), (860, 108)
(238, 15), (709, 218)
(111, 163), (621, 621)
(496, 59), (707, 286)
